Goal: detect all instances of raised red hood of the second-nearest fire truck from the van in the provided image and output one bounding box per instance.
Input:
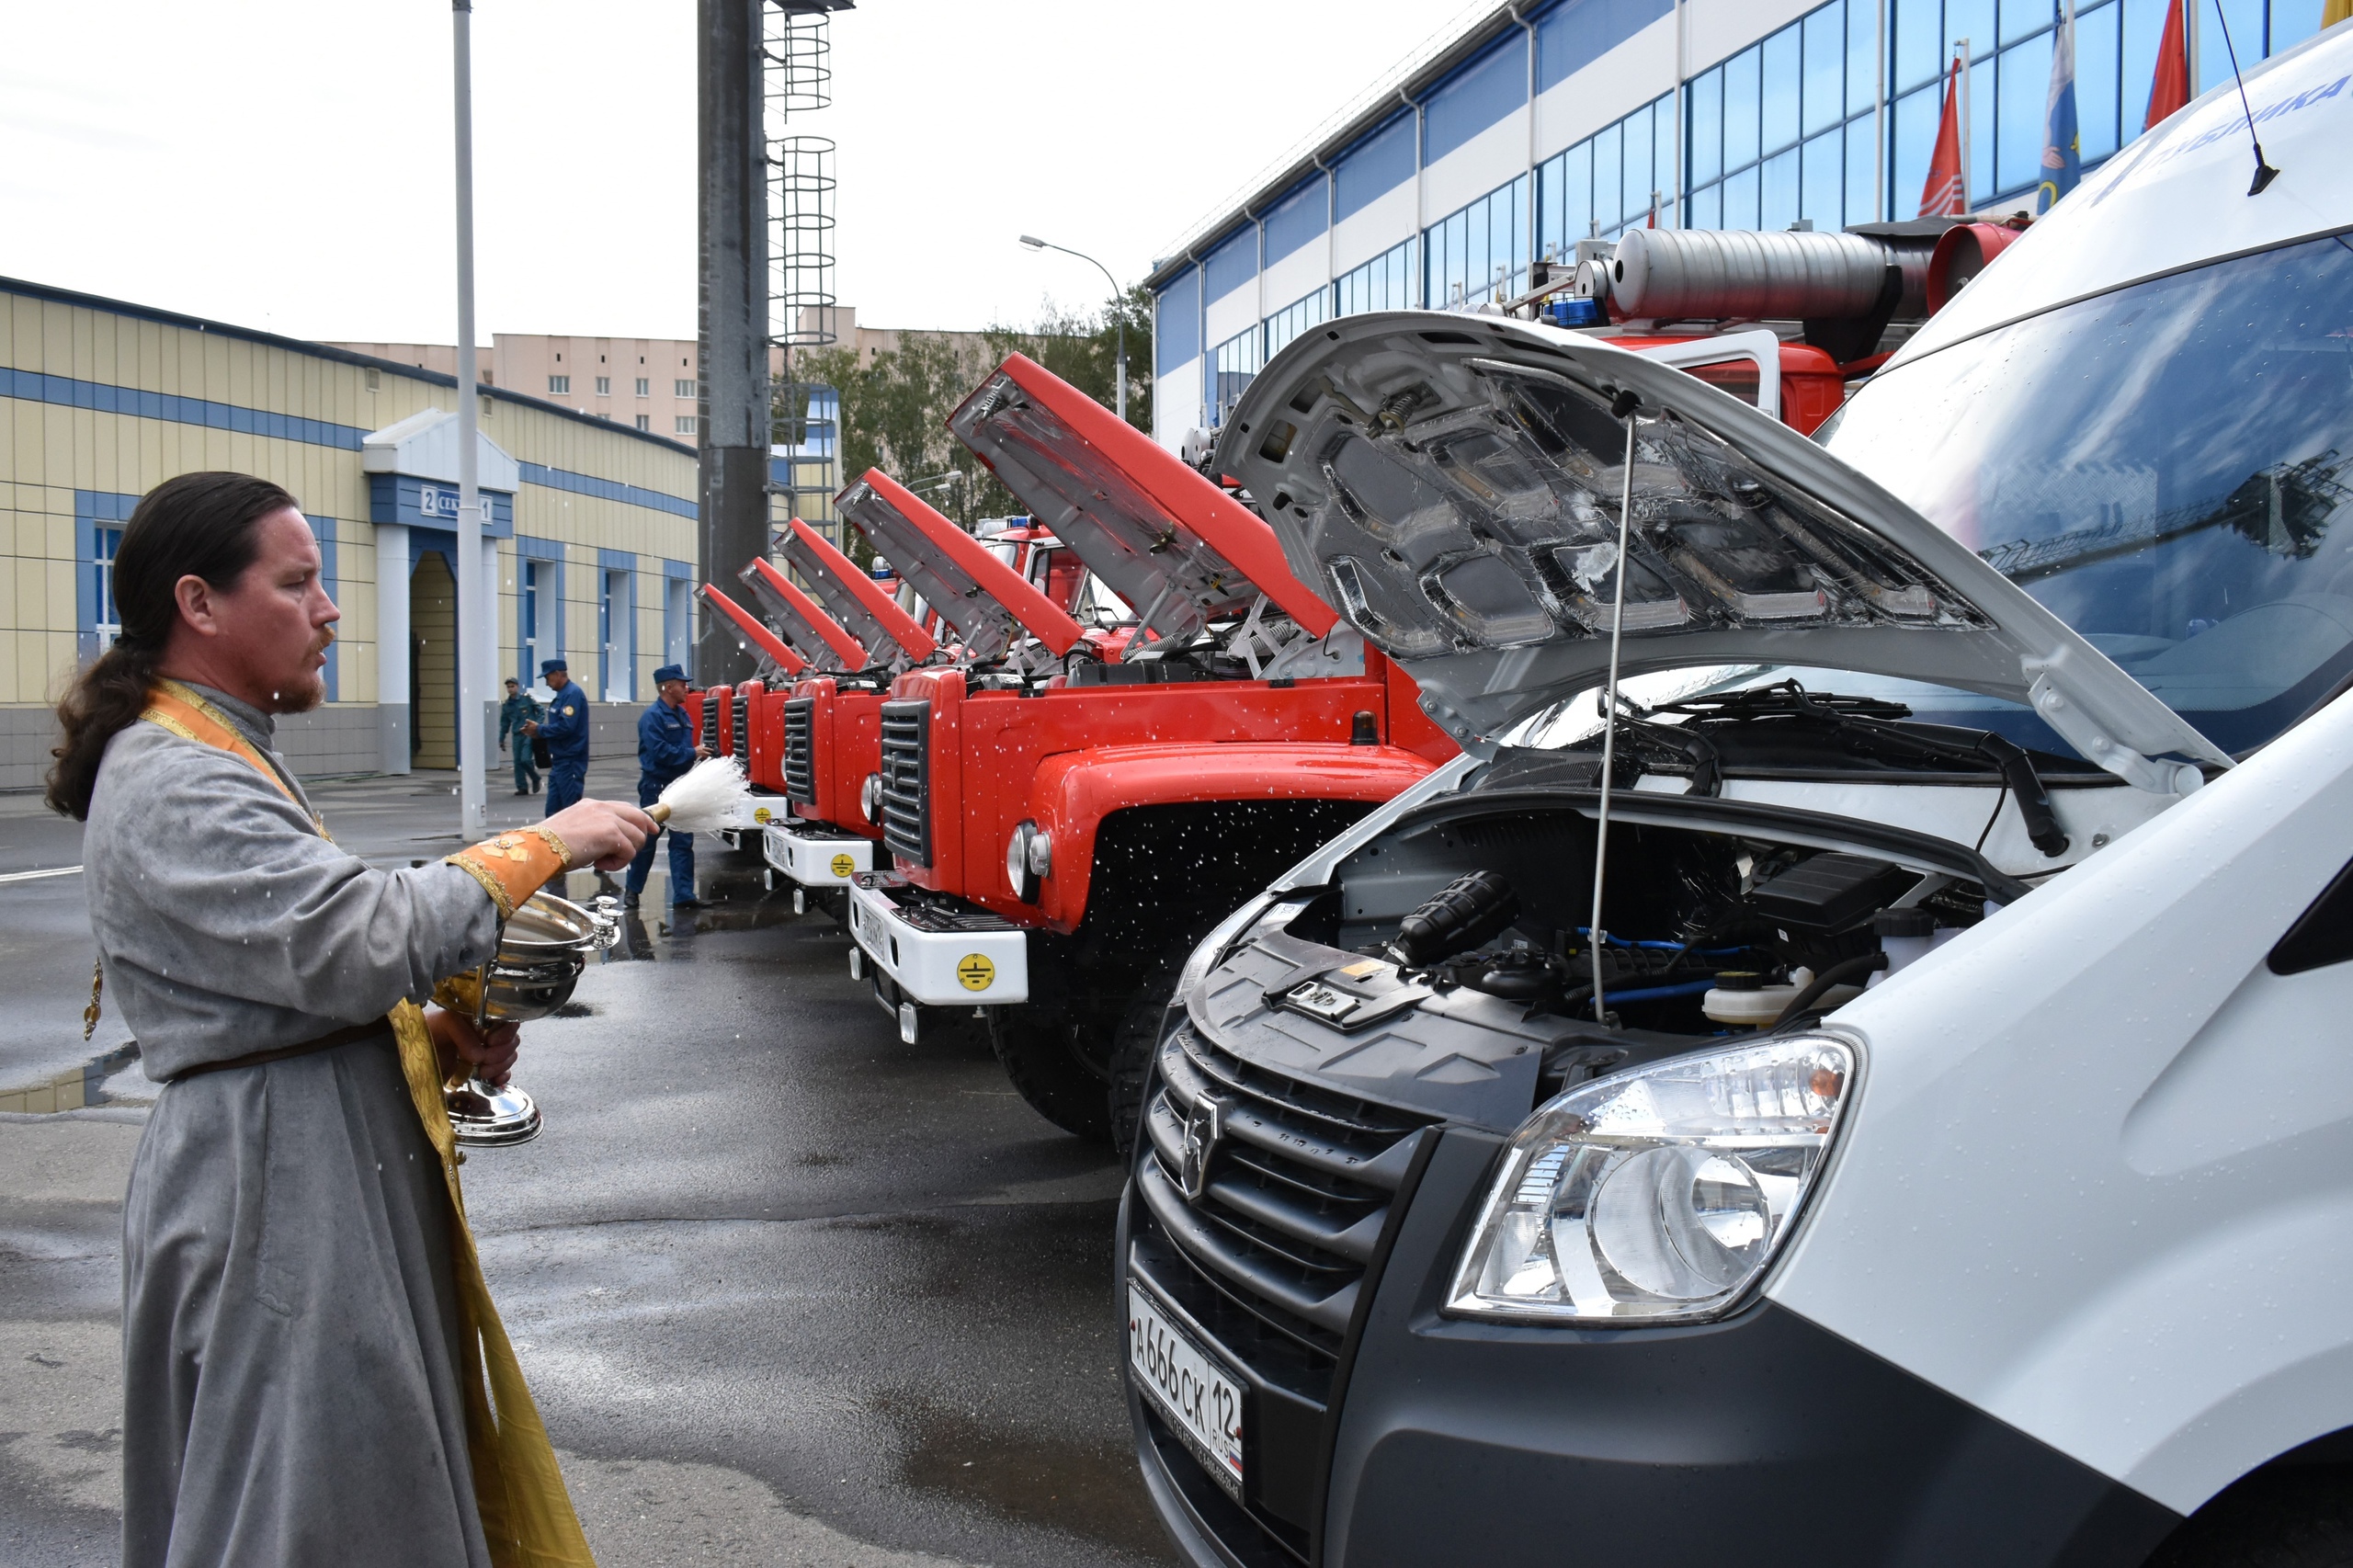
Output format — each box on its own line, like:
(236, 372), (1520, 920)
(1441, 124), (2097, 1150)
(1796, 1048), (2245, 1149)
(833, 469), (1080, 662)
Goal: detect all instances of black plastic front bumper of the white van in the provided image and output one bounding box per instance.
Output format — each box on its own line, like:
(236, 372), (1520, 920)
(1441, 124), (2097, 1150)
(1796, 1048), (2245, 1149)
(1118, 1128), (2179, 1568)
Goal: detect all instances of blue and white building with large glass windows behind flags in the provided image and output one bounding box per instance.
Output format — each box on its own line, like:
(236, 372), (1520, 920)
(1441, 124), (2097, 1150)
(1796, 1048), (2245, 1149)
(1146, 0), (2323, 445)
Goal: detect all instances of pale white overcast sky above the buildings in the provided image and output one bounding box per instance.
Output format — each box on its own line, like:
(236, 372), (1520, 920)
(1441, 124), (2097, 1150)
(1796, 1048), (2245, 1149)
(0, 0), (1475, 341)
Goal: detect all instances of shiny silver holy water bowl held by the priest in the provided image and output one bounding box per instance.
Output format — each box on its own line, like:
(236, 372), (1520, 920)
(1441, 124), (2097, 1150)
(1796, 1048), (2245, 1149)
(433, 892), (621, 1149)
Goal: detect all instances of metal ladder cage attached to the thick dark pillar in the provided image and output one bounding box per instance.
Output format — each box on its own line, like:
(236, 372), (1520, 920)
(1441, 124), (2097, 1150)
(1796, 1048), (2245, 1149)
(760, 0), (840, 544)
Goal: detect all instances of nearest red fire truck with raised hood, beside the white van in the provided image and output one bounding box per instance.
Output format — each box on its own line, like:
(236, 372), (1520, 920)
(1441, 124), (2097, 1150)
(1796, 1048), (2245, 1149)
(852, 356), (1454, 1137)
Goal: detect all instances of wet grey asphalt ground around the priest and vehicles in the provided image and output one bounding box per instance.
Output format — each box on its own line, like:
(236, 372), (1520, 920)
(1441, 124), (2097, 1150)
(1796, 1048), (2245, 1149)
(0, 767), (1174, 1568)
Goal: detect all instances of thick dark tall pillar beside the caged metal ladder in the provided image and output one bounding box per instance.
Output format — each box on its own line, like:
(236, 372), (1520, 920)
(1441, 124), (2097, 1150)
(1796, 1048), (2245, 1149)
(694, 0), (769, 685)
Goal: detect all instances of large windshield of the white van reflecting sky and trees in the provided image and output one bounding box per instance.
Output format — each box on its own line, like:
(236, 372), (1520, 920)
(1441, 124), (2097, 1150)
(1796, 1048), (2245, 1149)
(1826, 238), (2353, 751)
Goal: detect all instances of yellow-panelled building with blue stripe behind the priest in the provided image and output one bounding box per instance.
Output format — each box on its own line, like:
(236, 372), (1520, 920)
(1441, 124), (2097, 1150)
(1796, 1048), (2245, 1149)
(0, 278), (697, 789)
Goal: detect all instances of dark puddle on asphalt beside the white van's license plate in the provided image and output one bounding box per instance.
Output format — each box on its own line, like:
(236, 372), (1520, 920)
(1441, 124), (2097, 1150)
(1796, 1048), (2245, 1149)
(882, 1393), (1167, 1559)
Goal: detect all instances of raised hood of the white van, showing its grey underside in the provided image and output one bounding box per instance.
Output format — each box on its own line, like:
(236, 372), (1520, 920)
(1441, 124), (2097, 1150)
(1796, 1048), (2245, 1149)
(1217, 311), (2228, 793)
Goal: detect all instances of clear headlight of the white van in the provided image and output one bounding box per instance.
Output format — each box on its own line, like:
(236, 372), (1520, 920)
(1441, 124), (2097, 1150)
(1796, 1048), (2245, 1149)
(1447, 1034), (1854, 1324)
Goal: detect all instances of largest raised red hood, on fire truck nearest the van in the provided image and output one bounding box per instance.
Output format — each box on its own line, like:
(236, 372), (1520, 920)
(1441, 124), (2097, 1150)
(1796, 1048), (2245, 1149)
(949, 353), (1339, 638)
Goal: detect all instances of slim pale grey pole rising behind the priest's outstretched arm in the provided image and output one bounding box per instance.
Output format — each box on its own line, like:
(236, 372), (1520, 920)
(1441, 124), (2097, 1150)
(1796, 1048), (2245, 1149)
(449, 0), (492, 838)
